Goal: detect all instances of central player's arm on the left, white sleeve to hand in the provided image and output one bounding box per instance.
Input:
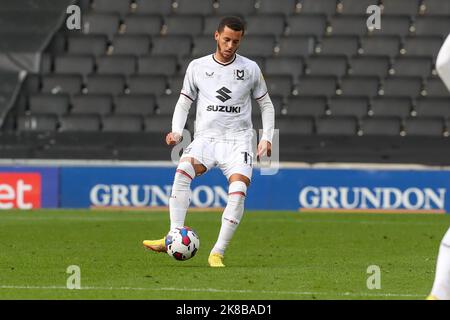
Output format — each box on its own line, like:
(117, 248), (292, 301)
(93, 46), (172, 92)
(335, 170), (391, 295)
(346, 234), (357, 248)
(166, 62), (197, 146)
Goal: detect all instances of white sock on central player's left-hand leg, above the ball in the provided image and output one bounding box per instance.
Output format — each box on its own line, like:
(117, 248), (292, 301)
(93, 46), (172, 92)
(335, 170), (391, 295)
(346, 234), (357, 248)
(169, 162), (195, 230)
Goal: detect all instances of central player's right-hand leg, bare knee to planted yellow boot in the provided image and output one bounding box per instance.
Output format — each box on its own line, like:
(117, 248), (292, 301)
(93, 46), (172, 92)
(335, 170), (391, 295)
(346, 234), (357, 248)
(208, 174), (250, 267)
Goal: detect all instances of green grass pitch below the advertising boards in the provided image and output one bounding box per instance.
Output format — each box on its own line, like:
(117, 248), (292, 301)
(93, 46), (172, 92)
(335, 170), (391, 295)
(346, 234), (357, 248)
(0, 210), (450, 300)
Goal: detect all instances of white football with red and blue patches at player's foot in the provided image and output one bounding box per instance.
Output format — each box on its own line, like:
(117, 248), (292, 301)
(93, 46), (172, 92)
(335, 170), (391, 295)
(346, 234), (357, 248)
(166, 226), (200, 261)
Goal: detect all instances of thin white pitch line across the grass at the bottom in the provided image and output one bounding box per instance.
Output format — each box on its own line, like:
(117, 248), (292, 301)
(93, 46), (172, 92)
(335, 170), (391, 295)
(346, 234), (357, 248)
(0, 285), (426, 298)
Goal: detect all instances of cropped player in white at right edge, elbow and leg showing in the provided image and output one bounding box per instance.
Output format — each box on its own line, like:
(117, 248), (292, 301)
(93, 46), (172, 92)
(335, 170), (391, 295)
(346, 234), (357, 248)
(427, 35), (450, 300)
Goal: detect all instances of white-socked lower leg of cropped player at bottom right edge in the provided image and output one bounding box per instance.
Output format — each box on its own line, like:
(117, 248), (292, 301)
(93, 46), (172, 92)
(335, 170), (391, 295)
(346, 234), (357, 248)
(431, 229), (450, 300)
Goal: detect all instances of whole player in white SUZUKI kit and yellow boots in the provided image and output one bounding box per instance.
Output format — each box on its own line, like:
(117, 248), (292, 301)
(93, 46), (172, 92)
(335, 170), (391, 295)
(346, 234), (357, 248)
(143, 17), (275, 267)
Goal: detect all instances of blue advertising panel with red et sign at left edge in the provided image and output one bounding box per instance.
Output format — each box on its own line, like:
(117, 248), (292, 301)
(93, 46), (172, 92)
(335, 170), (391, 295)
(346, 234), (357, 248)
(0, 166), (59, 209)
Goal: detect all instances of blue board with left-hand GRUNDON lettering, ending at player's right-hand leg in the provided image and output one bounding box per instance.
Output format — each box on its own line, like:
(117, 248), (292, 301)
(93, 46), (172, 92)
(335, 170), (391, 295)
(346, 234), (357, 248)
(61, 167), (227, 208)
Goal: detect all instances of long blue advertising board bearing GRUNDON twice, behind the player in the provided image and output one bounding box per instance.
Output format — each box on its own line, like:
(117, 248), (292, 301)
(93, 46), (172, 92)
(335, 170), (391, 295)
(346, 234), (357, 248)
(60, 167), (450, 213)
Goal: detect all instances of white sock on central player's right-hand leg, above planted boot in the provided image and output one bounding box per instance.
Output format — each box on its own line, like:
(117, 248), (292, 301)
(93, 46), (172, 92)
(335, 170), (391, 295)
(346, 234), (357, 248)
(211, 181), (247, 255)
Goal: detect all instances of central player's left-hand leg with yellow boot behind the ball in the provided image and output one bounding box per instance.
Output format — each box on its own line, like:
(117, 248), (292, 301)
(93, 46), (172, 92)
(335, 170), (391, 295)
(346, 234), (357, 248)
(143, 158), (206, 252)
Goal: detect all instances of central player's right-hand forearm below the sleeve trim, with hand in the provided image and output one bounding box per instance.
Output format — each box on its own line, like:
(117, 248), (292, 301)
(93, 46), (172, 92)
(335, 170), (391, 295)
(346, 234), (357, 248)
(256, 93), (275, 157)
